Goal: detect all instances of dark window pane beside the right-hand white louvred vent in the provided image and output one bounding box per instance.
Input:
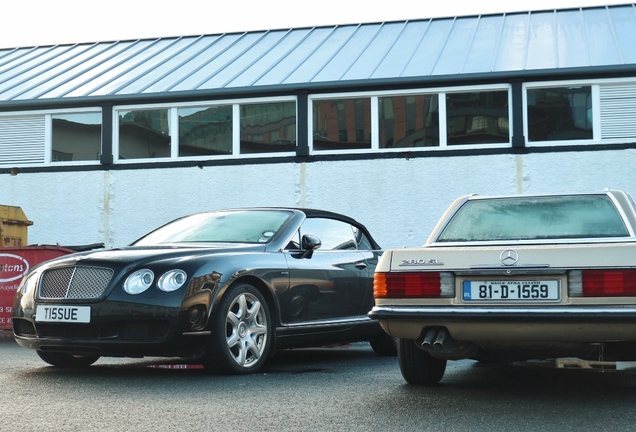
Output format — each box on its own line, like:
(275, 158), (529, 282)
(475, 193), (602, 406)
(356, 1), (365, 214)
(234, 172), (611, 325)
(527, 86), (593, 141)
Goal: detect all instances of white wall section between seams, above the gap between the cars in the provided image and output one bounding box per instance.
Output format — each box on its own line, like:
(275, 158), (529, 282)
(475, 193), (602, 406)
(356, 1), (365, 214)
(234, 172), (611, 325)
(300, 155), (516, 247)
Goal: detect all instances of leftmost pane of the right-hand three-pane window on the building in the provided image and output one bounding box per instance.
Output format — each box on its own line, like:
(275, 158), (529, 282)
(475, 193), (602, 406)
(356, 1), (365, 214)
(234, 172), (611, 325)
(313, 98), (371, 150)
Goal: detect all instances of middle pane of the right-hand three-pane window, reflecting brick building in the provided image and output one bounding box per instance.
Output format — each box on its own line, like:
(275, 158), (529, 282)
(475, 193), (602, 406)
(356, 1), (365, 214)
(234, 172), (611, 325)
(378, 94), (439, 148)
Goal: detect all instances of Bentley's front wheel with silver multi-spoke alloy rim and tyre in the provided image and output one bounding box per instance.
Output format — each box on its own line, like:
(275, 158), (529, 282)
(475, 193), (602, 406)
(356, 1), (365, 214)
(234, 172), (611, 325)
(202, 284), (273, 374)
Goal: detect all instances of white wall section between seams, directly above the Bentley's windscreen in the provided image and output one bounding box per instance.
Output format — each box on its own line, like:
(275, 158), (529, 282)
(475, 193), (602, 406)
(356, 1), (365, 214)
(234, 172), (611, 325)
(109, 164), (298, 246)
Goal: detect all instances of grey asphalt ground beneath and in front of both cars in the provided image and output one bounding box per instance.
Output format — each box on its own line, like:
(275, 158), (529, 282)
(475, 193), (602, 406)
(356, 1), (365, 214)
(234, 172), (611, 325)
(0, 338), (636, 432)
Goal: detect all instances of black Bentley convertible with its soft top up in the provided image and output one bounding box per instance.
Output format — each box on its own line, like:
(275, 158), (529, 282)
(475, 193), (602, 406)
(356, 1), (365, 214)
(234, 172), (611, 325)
(13, 208), (395, 373)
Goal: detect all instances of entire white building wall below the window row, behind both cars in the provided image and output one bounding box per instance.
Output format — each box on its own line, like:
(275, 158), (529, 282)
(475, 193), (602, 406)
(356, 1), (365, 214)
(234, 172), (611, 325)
(0, 149), (636, 248)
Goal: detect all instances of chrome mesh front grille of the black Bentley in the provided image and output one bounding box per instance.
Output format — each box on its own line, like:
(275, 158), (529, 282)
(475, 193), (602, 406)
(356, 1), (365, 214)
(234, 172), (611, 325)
(39, 267), (113, 300)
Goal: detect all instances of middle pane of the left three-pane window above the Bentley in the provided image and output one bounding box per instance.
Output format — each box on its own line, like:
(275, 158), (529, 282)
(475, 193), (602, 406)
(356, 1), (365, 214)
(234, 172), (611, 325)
(177, 105), (232, 157)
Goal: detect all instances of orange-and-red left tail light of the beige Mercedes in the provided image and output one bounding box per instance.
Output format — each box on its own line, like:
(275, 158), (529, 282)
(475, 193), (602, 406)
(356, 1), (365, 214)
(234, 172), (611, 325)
(373, 272), (455, 298)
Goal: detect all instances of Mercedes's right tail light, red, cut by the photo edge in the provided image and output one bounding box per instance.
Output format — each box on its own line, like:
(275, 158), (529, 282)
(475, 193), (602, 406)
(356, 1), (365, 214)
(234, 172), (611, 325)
(569, 269), (636, 297)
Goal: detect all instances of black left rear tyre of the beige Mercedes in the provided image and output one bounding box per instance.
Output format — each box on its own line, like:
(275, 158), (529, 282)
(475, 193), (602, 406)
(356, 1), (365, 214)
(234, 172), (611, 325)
(397, 339), (446, 385)
